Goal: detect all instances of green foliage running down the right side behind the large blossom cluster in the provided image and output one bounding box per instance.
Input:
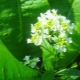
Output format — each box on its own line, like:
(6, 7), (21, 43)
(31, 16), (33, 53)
(49, 0), (80, 68)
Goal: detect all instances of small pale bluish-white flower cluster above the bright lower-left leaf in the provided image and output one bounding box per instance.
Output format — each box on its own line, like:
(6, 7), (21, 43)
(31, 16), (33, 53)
(23, 56), (40, 68)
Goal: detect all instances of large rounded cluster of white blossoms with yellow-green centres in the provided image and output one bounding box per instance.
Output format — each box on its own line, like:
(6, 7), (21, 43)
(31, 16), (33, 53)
(27, 9), (75, 53)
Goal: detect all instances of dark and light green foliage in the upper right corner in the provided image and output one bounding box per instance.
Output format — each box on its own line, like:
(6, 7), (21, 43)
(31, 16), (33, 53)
(49, 0), (80, 23)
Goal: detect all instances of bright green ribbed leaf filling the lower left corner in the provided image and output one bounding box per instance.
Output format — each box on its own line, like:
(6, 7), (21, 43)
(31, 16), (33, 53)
(0, 40), (40, 80)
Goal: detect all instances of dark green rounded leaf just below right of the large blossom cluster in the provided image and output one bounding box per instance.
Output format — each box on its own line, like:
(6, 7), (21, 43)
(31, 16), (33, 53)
(56, 44), (79, 69)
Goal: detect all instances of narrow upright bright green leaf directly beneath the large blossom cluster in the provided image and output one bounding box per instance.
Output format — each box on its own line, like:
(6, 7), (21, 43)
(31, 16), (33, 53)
(41, 39), (54, 71)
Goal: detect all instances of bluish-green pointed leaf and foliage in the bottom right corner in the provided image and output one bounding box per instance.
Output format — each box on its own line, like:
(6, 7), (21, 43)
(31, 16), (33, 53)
(56, 68), (80, 80)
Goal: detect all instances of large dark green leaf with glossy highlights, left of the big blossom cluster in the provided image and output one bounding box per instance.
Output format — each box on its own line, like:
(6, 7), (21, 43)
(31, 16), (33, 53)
(0, 0), (49, 60)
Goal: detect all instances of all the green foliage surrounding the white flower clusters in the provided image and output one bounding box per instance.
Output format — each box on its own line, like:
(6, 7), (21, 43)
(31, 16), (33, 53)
(0, 0), (80, 80)
